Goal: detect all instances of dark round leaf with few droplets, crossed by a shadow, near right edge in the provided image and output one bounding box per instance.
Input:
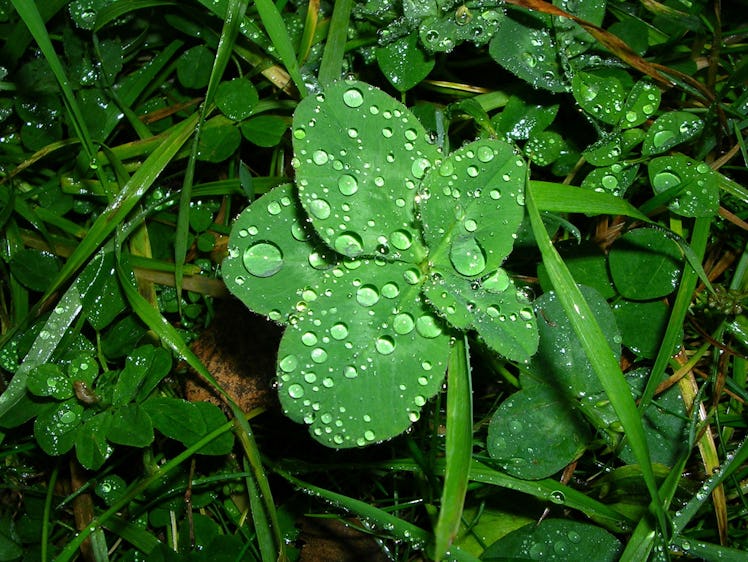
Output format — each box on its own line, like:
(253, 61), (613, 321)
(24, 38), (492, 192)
(608, 228), (683, 300)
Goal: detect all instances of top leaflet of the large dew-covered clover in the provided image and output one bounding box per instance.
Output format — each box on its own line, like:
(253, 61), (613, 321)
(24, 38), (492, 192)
(293, 81), (439, 263)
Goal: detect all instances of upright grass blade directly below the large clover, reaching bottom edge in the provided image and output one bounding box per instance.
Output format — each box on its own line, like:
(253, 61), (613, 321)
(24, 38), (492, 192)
(434, 336), (473, 560)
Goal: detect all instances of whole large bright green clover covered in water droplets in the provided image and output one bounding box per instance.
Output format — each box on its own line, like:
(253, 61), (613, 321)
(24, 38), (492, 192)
(223, 81), (538, 447)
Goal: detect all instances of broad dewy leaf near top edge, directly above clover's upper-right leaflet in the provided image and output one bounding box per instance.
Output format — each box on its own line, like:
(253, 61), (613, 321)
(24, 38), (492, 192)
(489, 6), (568, 92)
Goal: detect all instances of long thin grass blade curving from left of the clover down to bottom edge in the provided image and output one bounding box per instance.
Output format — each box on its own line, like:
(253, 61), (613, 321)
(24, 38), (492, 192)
(117, 252), (285, 557)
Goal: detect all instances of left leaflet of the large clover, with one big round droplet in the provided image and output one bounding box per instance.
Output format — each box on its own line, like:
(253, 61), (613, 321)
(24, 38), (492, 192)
(222, 184), (338, 322)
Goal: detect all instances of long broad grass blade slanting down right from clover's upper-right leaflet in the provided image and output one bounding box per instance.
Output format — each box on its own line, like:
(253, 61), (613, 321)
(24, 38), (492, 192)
(526, 184), (667, 533)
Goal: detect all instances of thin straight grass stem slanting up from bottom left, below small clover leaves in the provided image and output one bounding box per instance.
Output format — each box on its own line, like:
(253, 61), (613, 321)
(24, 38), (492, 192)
(55, 421), (235, 562)
